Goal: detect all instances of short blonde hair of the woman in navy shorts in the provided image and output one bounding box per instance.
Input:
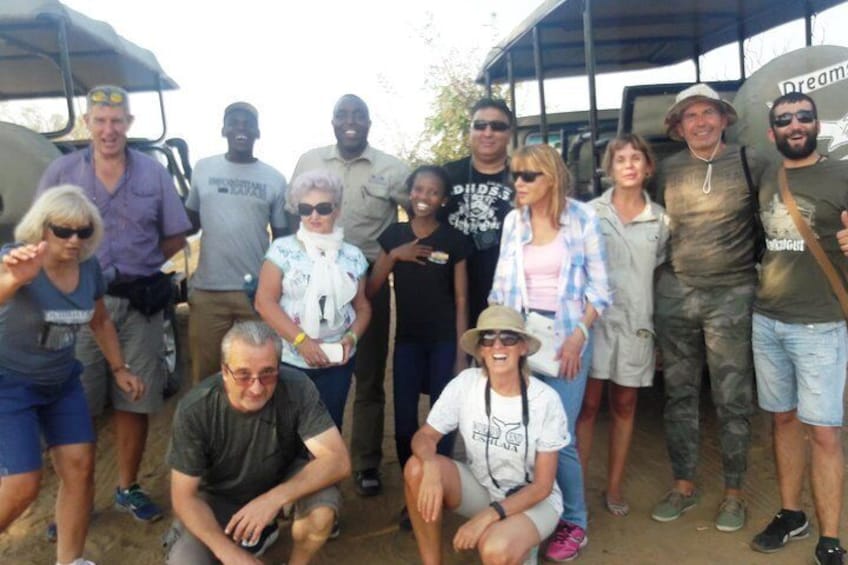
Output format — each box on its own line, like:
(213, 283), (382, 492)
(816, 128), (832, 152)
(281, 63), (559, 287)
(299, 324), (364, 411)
(15, 184), (103, 261)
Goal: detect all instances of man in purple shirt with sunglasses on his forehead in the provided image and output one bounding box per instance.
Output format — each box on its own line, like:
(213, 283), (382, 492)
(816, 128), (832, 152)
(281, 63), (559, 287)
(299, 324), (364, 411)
(38, 86), (191, 522)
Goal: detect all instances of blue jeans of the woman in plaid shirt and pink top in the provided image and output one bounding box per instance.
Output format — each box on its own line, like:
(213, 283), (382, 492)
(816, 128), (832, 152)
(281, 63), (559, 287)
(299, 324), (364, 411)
(534, 337), (592, 530)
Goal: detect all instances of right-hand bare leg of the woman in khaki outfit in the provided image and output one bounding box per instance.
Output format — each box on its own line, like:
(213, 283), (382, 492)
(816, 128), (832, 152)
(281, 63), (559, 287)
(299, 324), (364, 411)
(607, 382), (639, 502)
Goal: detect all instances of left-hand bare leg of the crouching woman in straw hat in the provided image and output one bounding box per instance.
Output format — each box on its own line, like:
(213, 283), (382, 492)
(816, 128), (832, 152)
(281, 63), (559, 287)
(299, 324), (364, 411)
(403, 455), (462, 565)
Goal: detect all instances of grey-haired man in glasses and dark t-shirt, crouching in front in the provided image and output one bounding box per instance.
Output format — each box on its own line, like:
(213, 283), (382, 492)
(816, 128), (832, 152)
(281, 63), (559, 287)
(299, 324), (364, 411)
(166, 321), (350, 565)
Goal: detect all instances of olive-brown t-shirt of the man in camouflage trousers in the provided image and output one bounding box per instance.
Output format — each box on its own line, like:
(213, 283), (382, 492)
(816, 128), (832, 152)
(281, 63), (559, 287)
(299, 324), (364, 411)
(657, 145), (766, 288)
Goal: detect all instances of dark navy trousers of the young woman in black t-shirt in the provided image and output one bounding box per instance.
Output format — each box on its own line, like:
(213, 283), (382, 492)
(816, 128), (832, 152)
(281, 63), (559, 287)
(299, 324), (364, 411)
(393, 340), (456, 470)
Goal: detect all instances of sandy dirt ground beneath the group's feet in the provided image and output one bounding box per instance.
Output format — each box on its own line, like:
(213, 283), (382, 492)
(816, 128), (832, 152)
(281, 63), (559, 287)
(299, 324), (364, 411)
(0, 306), (840, 565)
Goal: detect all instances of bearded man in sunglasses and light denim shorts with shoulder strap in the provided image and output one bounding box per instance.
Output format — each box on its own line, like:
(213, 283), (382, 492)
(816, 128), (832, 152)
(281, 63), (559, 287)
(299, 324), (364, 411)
(751, 92), (848, 565)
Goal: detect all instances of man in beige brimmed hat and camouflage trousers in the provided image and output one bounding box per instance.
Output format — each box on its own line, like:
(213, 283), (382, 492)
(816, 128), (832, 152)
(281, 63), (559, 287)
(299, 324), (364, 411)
(652, 84), (765, 532)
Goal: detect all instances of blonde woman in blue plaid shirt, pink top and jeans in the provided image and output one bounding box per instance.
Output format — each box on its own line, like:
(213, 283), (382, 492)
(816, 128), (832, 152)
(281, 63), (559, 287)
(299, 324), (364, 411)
(489, 145), (611, 561)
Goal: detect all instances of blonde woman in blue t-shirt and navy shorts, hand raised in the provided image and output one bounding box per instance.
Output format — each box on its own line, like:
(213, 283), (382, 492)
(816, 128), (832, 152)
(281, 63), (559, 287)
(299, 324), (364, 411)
(0, 185), (144, 565)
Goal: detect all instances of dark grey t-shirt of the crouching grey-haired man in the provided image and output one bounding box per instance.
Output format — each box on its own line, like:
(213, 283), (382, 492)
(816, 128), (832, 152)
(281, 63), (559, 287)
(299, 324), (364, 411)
(167, 367), (335, 504)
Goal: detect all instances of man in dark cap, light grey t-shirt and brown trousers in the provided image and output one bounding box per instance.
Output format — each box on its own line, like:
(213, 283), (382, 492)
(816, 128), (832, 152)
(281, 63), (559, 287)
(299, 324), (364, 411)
(186, 102), (288, 383)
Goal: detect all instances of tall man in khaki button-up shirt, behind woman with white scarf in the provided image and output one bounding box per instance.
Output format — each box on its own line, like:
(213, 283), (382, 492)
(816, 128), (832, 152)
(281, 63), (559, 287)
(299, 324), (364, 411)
(292, 94), (409, 496)
